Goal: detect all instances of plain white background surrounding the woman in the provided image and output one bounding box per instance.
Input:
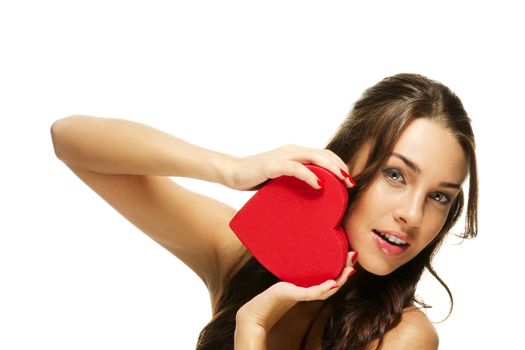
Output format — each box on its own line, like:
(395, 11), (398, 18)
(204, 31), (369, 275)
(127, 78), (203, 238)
(0, 0), (525, 349)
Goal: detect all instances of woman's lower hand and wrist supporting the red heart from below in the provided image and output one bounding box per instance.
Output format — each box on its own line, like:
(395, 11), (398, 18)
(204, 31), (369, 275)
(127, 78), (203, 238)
(235, 252), (357, 349)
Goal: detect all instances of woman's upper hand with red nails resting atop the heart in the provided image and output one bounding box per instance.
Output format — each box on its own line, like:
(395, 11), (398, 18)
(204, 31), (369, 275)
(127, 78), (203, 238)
(226, 145), (354, 190)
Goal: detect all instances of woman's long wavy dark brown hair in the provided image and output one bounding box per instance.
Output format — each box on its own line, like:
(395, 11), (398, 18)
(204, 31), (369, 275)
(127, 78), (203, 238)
(197, 74), (478, 350)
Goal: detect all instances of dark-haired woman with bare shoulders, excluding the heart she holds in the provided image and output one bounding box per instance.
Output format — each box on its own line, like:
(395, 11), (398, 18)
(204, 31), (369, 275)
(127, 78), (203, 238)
(51, 74), (477, 349)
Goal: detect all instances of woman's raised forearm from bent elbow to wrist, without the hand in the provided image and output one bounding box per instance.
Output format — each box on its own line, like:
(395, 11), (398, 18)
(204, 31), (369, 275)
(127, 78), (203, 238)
(51, 116), (234, 184)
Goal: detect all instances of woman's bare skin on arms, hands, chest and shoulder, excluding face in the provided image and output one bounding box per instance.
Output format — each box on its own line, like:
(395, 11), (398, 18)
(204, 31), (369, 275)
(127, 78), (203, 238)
(51, 116), (437, 350)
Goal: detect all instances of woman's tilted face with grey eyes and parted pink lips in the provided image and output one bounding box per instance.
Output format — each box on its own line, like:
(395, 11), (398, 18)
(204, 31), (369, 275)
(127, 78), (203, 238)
(342, 118), (467, 275)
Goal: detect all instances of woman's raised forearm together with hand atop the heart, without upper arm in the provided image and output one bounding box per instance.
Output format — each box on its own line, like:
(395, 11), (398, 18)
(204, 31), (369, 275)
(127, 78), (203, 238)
(51, 116), (352, 190)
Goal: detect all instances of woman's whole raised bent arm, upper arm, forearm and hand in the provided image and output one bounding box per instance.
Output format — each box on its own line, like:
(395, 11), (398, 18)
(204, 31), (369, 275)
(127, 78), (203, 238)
(51, 116), (351, 296)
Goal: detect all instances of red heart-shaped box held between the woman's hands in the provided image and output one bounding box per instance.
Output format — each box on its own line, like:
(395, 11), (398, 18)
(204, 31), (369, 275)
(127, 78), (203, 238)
(230, 164), (348, 287)
